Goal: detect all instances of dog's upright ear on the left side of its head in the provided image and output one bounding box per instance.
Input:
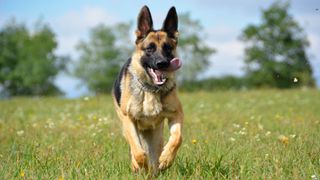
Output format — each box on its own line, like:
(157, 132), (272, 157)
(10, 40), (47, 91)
(136, 6), (153, 40)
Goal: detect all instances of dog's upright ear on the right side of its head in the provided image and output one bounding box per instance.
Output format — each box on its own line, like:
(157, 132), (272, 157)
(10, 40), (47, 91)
(161, 6), (178, 38)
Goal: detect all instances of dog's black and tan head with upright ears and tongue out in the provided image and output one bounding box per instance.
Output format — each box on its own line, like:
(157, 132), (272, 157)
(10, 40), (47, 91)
(135, 6), (181, 86)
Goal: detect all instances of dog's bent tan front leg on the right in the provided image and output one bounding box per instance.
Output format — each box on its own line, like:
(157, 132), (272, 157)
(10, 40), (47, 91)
(159, 110), (183, 170)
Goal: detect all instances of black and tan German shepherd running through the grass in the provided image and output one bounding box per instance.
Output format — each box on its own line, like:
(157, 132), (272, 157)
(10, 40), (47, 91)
(112, 6), (183, 174)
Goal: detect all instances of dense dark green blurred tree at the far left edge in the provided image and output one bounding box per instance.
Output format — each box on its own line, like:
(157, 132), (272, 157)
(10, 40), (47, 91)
(0, 20), (66, 96)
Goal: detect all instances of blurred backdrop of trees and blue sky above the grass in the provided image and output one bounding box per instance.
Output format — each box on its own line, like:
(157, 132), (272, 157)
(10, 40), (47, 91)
(0, 0), (320, 98)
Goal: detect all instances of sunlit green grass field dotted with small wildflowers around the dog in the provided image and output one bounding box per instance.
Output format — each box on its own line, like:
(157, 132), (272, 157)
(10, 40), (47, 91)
(0, 90), (320, 179)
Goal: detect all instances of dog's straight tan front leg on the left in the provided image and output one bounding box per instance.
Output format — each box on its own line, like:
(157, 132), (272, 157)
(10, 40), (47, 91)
(121, 116), (147, 171)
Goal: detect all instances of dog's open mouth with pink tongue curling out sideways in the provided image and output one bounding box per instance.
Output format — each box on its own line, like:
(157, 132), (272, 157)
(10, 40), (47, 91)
(148, 58), (182, 86)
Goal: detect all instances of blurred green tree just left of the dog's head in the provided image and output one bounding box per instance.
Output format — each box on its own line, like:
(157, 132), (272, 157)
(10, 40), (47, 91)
(74, 23), (134, 93)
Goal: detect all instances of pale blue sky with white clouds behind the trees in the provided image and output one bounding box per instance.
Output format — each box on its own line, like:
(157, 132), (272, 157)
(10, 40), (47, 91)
(0, 0), (320, 98)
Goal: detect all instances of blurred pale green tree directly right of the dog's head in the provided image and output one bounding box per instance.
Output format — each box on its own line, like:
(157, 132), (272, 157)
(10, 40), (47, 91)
(178, 13), (215, 83)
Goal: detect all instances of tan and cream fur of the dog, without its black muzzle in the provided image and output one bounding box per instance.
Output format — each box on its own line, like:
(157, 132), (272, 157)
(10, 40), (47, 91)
(114, 5), (183, 173)
